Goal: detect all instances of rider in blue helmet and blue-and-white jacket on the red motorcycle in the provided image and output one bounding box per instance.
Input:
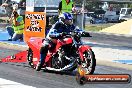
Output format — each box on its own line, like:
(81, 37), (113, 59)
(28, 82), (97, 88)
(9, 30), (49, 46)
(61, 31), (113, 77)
(36, 12), (83, 71)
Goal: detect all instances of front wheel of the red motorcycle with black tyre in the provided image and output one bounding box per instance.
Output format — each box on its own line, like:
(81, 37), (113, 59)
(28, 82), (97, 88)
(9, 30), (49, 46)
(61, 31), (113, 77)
(82, 50), (96, 74)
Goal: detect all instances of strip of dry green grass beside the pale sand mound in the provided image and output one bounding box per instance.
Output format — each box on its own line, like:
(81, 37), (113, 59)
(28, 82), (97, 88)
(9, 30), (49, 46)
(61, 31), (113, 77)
(85, 23), (114, 32)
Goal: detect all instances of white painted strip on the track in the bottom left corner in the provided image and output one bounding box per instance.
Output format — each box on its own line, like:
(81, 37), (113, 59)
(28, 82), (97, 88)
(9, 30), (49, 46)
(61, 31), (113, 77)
(0, 78), (36, 88)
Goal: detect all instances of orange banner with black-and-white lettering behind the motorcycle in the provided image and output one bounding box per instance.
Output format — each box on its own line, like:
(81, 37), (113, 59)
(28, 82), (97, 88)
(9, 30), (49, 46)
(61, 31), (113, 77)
(24, 11), (46, 42)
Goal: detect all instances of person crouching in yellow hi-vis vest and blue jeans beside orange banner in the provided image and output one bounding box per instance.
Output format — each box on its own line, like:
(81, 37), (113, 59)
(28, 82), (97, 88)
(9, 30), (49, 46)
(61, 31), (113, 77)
(7, 11), (24, 41)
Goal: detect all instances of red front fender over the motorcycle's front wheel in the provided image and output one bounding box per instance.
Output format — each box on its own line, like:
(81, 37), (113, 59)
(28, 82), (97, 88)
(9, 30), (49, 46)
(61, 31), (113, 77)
(78, 45), (91, 61)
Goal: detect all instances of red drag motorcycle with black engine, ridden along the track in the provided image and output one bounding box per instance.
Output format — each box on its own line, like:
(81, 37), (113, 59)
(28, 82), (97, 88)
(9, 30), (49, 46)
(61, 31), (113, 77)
(27, 31), (96, 74)
